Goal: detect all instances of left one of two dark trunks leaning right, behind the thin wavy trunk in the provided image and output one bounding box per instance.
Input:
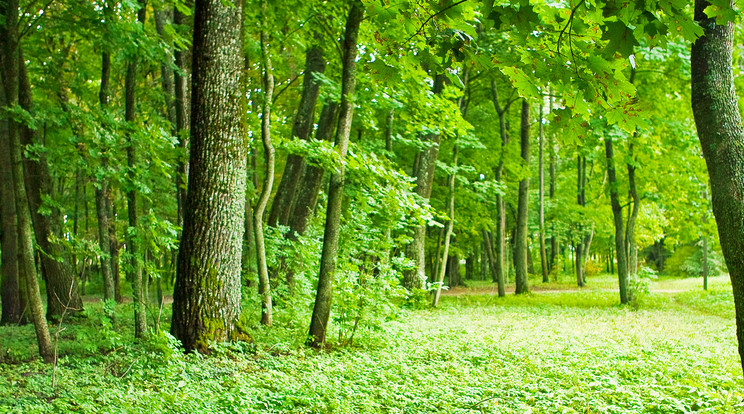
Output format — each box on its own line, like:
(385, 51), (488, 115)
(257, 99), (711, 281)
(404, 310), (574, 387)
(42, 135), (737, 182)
(269, 45), (326, 226)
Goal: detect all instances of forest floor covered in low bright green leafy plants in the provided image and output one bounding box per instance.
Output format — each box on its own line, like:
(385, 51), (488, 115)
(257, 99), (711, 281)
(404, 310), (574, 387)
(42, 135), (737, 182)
(0, 276), (744, 414)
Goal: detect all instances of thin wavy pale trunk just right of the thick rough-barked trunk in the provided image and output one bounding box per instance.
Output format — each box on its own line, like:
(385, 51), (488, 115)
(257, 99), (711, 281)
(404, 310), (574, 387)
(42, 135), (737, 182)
(253, 4), (274, 326)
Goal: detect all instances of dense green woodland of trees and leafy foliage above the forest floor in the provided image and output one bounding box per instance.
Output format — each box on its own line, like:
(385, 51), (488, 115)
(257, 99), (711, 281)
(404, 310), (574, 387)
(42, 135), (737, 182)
(0, 0), (744, 412)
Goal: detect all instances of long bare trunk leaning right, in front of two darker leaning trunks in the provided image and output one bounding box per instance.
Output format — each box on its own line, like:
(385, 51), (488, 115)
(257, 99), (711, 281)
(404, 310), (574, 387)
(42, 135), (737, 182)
(307, 1), (364, 348)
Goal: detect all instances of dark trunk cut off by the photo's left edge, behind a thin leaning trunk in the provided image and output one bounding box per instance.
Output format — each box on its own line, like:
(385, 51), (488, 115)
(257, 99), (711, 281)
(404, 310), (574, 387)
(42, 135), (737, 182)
(0, 66), (24, 325)
